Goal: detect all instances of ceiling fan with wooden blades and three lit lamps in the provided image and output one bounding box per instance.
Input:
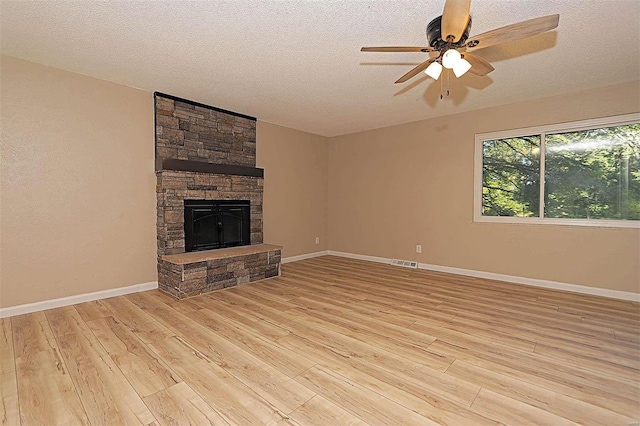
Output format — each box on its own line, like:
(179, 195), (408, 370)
(360, 0), (560, 99)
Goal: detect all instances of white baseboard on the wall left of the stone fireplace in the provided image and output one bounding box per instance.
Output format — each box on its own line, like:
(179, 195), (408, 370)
(0, 281), (158, 318)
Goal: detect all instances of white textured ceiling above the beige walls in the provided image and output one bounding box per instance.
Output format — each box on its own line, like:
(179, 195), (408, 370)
(0, 0), (640, 136)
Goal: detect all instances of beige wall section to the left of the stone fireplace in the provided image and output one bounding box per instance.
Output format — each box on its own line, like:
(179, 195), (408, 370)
(0, 56), (157, 307)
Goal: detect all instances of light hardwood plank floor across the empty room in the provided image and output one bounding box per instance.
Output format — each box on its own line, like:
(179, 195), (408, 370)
(0, 257), (640, 426)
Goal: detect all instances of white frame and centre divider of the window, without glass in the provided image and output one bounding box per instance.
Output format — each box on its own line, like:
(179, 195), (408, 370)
(473, 113), (640, 228)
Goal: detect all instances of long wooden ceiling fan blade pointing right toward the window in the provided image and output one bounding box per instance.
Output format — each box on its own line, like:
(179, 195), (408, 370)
(466, 15), (560, 50)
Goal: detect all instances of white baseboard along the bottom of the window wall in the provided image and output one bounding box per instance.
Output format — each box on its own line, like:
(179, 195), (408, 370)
(328, 250), (640, 302)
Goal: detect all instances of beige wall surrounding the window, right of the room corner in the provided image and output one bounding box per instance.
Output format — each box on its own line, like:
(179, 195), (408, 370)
(328, 82), (640, 292)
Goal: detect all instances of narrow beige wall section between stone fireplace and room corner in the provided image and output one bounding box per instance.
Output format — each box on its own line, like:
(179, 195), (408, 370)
(257, 121), (328, 257)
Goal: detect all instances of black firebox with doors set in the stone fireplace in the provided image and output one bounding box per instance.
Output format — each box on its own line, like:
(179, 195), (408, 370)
(184, 200), (251, 252)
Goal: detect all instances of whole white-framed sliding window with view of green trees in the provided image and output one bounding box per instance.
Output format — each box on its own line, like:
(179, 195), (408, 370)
(474, 114), (640, 228)
